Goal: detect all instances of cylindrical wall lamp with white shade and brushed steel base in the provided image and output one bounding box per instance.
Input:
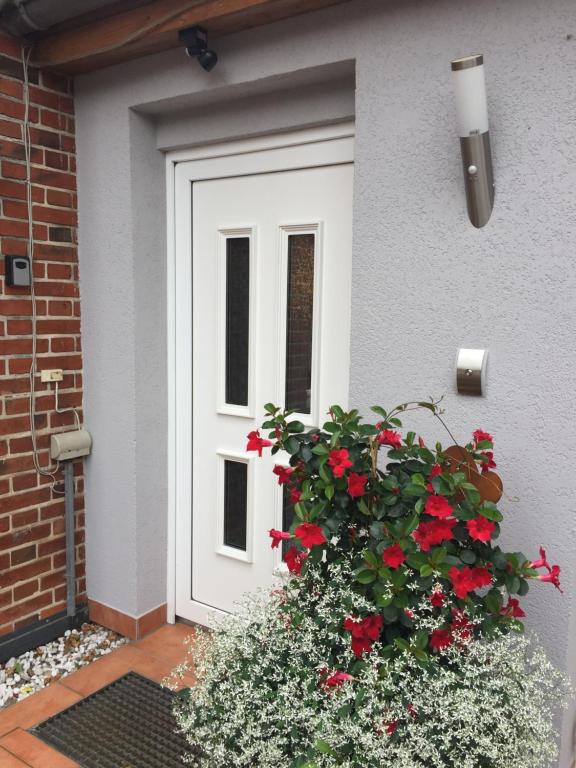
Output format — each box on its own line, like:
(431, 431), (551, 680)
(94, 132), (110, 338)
(452, 54), (494, 228)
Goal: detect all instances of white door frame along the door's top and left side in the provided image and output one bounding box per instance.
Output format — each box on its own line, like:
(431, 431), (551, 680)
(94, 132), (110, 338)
(166, 122), (355, 624)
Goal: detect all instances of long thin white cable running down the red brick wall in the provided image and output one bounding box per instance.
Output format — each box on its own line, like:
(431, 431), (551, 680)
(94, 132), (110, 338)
(22, 48), (62, 494)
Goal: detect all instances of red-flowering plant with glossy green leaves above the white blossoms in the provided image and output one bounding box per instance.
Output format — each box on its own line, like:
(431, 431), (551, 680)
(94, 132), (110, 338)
(253, 402), (560, 661)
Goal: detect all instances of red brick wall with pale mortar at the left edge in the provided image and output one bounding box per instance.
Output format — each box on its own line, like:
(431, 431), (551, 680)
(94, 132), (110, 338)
(0, 32), (86, 635)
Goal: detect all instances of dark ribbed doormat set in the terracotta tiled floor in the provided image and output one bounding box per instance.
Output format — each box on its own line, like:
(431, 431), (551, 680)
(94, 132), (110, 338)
(30, 672), (189, 768)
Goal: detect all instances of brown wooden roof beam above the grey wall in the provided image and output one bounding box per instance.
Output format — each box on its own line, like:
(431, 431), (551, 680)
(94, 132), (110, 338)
(33, 0), (354, 74)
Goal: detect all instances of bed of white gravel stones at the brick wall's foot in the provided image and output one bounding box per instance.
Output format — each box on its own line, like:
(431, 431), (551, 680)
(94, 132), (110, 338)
(0, 624), (130, 708)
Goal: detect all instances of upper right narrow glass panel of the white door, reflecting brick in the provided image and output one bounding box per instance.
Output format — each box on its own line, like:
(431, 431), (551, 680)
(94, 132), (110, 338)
(286, 234), (315, 413)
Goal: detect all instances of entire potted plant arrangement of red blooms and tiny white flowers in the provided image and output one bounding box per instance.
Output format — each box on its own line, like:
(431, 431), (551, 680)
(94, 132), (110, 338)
(176, 402), (568, 768)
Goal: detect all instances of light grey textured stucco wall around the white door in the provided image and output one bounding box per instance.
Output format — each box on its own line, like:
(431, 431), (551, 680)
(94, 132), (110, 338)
(76, 0), (576, 768)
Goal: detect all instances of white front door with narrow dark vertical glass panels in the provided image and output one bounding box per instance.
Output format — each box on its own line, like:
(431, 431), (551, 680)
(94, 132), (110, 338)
(175, 126), (353, 623)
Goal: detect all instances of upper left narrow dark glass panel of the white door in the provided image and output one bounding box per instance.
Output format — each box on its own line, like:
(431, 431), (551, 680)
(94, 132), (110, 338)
(226, 237), (250, 405)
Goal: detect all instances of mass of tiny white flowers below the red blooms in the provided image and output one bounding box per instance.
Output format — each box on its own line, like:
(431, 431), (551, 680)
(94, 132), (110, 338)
(176, 564), (568, 768)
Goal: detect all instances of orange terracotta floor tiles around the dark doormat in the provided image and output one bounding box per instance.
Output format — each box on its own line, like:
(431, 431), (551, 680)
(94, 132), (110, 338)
(0, 624), (193, 768)
